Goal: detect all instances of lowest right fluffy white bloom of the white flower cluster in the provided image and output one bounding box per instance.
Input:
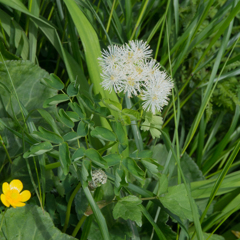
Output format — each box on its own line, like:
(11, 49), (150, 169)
(141, 70), (173, 114)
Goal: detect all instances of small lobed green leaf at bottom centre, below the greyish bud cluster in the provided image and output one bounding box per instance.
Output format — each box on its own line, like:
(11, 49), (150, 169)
(113, 195), (142, 227)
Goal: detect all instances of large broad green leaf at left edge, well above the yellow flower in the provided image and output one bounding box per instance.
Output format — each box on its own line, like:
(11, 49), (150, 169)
(0, 61), (57, 117)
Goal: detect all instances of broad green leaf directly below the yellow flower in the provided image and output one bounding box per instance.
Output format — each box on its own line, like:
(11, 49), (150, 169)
(0, 205), (76, 240)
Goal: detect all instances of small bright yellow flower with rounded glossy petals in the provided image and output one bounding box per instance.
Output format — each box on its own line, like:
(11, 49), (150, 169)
(1, 179), (31, 208)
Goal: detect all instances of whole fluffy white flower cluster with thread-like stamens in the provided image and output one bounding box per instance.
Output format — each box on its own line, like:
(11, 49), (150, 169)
(99, 40), (173, 114)
